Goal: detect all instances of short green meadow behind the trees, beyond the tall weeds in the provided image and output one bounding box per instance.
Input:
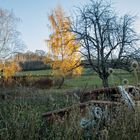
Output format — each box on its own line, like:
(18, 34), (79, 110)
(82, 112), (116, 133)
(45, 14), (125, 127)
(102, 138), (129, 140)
(16, 68), (136, 89)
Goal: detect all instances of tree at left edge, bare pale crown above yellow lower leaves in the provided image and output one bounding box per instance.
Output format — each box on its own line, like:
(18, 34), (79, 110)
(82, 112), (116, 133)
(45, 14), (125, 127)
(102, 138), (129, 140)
(0, 8), (25, 79)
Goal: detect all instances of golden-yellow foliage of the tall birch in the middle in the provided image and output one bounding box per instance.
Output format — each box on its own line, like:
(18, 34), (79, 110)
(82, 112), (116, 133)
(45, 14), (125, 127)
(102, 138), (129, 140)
(47, 7), (82, 76)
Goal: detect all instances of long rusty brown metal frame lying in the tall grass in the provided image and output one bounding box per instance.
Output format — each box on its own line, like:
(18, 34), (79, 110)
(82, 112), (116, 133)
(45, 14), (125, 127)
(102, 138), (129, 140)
(42, 87), (122, 121)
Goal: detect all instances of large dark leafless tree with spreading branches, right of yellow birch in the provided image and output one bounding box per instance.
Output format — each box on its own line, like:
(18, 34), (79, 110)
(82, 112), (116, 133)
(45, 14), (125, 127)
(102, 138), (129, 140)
(71, 0), (138, 87)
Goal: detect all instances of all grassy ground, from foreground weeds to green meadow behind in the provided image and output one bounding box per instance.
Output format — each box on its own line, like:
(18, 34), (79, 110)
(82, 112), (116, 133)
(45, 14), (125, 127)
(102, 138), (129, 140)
(0, 69), (140, 140)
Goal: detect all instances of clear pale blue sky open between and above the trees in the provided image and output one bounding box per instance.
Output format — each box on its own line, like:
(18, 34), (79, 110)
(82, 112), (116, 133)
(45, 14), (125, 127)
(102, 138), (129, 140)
(0, 0), (140, 51)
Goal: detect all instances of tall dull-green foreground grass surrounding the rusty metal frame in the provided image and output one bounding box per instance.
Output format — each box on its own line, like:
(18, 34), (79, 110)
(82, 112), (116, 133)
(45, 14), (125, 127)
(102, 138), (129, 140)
(0, 92), (140, 140)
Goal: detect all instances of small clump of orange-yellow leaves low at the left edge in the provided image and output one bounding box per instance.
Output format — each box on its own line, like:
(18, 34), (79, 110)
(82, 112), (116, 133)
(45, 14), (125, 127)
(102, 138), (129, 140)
(0, 61), (20, 79)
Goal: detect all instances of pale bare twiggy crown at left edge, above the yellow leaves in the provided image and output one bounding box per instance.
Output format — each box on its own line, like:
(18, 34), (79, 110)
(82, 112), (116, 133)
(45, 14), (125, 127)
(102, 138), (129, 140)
(0, 8), (25, 59)
